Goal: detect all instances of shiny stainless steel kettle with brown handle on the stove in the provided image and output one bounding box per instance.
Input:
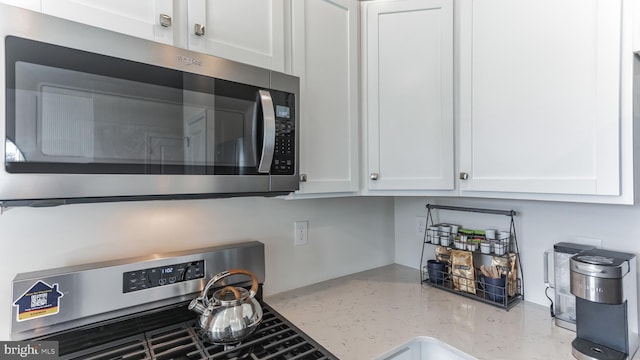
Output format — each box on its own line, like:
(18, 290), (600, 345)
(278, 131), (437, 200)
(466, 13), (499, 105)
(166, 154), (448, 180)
(189, 269), (262, 345)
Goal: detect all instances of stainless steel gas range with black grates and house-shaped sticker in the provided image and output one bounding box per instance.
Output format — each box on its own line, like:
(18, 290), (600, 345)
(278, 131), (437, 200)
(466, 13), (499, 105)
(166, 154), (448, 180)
(11, 241), (337, 360)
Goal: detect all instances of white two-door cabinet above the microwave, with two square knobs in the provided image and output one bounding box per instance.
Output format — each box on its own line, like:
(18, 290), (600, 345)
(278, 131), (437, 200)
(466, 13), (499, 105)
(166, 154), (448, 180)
(28, 0), (287, 72)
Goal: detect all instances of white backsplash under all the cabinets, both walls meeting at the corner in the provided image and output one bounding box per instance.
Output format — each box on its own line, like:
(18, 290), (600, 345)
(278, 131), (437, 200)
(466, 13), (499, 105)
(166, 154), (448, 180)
(0, 193), (640, 340)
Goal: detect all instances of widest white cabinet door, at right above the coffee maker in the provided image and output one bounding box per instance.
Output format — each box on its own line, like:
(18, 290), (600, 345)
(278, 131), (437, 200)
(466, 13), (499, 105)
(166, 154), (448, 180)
(460, 0), (622, 198)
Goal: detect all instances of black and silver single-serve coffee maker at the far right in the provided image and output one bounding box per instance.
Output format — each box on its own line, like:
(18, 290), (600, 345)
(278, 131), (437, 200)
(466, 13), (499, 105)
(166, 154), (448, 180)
(570, 249), (638, 360)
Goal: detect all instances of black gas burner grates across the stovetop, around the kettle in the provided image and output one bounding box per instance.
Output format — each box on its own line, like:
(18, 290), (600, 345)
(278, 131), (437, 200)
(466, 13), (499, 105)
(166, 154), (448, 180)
(52, 304), (336, 360)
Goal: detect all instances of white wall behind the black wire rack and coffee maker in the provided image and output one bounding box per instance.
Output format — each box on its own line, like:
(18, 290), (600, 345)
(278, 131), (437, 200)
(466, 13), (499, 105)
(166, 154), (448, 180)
(395, 197), (640, 305)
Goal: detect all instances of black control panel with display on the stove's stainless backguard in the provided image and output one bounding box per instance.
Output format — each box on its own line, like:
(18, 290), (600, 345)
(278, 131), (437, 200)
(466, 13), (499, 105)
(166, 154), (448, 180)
(122, 260), (204, 293)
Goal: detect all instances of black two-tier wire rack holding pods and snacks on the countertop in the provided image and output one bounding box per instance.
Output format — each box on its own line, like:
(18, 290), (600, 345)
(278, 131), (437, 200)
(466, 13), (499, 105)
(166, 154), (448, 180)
(420, 204), (524, 311)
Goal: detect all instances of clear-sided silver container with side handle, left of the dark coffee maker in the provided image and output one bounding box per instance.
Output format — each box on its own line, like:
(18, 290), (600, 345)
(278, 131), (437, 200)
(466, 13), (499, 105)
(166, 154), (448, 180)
(544, 242), (595, 331)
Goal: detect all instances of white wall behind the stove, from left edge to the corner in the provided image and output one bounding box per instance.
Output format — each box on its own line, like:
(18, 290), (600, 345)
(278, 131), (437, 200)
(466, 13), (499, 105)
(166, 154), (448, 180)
(0, 198), (394, 340)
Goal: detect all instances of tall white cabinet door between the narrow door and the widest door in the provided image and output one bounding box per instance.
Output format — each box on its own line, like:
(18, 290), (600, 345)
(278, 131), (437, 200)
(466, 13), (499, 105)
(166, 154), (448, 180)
(362, 0), (454, 190)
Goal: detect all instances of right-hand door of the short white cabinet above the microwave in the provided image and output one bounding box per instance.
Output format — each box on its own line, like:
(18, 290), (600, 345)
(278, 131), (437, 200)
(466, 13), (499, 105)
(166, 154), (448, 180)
(187, 0), (284, 72)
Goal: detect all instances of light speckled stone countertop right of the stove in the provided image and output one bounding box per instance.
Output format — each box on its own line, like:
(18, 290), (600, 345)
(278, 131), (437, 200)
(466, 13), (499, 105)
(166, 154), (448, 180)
(265, 264), (620, 360)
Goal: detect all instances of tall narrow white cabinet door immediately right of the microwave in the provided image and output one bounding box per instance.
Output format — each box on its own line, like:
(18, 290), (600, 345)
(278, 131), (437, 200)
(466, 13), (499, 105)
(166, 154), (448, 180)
(292, 0), (359, 194)
